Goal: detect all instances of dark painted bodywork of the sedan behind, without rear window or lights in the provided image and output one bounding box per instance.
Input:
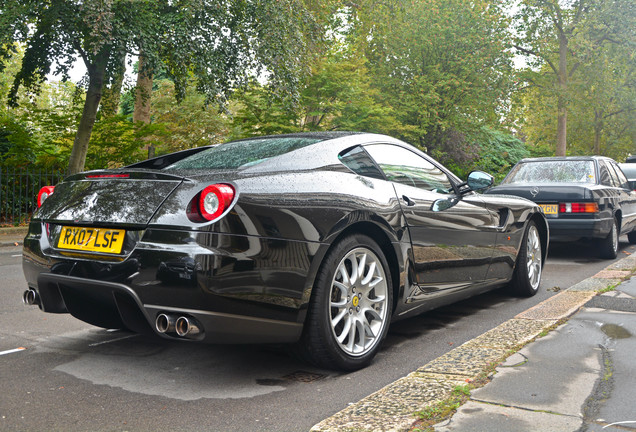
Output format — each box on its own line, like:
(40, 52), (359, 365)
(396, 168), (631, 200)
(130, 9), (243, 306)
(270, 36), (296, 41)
(486, 156), (636, 241)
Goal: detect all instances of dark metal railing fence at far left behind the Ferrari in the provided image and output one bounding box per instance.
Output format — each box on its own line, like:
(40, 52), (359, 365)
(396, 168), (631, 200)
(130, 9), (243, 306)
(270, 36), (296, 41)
(0, 164), (66, 226)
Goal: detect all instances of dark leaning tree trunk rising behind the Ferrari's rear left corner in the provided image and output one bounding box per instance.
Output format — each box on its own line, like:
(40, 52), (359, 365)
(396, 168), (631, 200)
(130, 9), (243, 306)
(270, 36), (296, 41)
(68, 53), (108, 174)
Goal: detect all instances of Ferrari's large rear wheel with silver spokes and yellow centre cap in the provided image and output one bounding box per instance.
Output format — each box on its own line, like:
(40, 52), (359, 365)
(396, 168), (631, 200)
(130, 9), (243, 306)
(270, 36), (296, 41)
(298, 234), (393, 371)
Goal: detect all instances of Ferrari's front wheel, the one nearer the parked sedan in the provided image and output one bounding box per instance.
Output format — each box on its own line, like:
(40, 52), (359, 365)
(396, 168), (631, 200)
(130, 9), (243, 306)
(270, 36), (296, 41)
(512, 221), (543, 297)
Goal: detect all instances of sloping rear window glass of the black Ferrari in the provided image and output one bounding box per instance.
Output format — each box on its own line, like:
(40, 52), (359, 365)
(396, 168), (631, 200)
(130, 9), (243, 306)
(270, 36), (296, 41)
(164, 137), (323, 170)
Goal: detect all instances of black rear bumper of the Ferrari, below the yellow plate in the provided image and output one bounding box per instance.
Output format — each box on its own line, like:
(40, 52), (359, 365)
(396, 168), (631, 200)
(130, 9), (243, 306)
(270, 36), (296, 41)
(23, 224), (326, 343)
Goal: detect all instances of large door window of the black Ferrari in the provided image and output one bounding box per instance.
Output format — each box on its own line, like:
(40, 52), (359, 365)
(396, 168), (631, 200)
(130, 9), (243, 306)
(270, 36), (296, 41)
(365, 144), (454, 194)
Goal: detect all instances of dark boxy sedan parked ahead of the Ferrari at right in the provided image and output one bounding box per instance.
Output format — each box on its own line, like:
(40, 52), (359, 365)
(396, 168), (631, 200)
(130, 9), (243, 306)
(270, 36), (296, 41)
(487, 156), (636, 258)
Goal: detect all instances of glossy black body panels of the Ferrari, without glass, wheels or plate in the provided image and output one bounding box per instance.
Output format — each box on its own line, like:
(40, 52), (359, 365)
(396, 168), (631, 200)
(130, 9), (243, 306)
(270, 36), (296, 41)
(23, 134), (547, 342)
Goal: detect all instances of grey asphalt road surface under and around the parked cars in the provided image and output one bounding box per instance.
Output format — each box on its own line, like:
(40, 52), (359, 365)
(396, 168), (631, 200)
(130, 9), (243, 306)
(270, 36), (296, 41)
(0, 238), (636, 431)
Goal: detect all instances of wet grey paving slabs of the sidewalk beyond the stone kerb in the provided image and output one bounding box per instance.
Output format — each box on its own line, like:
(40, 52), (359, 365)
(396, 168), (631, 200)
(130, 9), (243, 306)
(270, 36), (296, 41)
(435, 279), (636, 432)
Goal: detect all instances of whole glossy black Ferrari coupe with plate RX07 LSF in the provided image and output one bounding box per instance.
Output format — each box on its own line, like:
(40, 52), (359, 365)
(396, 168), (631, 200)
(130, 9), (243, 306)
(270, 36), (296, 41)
(23, 133), (548, 370)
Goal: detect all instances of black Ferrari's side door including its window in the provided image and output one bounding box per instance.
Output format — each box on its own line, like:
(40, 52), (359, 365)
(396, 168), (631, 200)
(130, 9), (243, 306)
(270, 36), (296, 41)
(365, 144), (496, 299)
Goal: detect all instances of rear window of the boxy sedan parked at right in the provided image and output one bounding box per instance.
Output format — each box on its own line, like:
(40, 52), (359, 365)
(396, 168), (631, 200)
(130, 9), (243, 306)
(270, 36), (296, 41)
(502, 160), (596, 184)
